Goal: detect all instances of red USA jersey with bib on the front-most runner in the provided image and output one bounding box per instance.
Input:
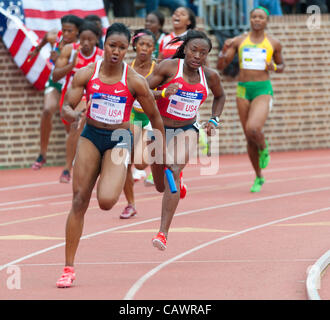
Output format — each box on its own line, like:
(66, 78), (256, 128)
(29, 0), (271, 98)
(86, 60), (135, 124)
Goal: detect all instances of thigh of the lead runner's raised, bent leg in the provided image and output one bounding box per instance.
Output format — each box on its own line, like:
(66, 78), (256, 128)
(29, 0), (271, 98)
(97, 148), (130, 198)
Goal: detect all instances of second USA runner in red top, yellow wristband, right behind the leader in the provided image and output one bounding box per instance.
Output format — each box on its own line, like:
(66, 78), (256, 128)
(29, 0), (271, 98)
(147, 30), (225, 250)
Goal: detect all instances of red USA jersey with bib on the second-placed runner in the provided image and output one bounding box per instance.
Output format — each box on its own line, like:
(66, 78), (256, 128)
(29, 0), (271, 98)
(157, 59), (208, 121)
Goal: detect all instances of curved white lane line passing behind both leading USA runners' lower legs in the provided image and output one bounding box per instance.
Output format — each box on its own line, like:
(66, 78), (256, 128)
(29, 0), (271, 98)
(0, 187), (330, 271)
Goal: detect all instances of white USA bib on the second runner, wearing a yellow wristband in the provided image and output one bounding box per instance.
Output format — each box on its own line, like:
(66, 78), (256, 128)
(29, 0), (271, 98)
(167, 90), (203, 119)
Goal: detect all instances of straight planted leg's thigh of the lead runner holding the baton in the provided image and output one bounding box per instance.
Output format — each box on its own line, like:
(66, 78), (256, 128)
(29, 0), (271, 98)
(73, 137), (101, 194)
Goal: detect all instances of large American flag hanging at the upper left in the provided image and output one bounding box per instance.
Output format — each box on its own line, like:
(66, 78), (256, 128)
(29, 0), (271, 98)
(0, 0), (109, 90)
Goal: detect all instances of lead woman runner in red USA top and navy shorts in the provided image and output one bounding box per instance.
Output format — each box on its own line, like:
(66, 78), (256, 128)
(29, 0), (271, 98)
(56, 23), (166, 288)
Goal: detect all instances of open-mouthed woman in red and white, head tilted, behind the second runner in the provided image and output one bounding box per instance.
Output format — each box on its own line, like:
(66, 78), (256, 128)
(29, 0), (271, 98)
(158, 7), (196, 60)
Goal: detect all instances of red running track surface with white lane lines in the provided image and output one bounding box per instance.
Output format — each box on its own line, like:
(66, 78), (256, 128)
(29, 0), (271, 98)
(0, 150), (330, 300)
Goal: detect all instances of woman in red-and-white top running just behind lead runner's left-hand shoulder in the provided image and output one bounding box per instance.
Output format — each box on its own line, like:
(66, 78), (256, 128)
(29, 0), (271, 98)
(53, 21), (103, 183)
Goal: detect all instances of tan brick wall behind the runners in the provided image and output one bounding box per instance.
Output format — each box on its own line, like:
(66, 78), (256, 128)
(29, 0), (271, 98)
(0, 15), (330, 168)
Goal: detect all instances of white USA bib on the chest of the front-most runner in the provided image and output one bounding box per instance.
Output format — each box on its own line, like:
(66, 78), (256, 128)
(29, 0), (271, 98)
(90, 93), (127, 124)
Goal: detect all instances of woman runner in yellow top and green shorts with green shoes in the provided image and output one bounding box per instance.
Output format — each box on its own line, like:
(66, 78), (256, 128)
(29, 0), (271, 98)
(217, 7), (284, 192)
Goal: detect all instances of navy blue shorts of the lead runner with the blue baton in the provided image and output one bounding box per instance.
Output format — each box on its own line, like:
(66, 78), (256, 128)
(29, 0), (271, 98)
(81, 123), (133, 156)
